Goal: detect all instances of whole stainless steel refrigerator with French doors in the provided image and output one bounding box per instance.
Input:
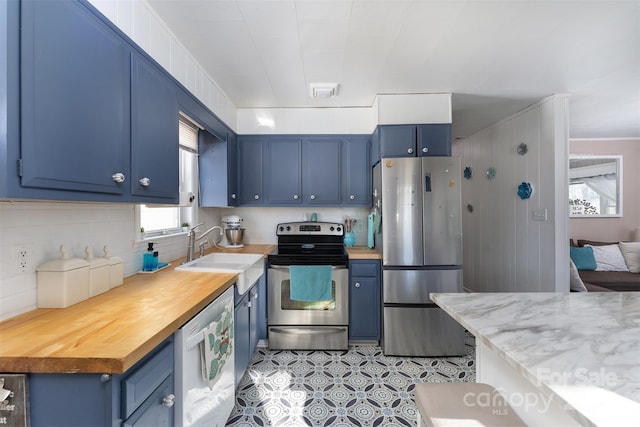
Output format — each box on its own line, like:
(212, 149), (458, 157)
(373, 157), (466, 356)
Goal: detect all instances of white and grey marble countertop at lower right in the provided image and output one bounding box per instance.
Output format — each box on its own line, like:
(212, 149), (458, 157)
(431, 292), (640, 425)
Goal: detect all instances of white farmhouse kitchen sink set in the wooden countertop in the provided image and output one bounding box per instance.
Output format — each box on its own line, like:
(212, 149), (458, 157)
(176, 252), (264, 295)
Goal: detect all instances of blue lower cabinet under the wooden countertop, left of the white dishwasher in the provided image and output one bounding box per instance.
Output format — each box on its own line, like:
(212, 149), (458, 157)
(29, 338), (174, 427)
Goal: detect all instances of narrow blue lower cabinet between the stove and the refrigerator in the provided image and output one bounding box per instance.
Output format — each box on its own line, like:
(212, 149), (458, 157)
(349, 260), (382, 341)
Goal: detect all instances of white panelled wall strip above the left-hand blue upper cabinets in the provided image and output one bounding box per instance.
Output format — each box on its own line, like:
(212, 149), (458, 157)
(89, 0), (236, 130)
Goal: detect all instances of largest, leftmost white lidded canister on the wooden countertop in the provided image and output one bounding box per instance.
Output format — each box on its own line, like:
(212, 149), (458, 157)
(36, 245), (89, 308)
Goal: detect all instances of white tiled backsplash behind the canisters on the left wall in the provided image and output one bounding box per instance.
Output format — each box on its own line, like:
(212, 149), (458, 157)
(0, 201), (208, 320)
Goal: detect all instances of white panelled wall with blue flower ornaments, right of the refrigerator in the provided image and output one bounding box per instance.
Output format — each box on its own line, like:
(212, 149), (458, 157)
(452, 95), (569, 292)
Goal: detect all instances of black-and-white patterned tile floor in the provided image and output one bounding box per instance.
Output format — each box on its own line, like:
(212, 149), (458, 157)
(227, 336), (475, 427)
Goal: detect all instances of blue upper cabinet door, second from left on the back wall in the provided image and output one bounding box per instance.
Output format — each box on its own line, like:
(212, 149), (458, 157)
(265, 139), (302, 206)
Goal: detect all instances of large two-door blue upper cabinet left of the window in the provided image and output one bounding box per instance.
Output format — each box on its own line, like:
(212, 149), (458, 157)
(11, 0), (179, 203)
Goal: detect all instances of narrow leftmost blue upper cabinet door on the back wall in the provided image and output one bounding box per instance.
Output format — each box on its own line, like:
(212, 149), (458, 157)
(238, 137), (264, 205)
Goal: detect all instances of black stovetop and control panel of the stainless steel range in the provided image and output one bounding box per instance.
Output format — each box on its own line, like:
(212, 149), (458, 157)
(268, 221), (349, 265)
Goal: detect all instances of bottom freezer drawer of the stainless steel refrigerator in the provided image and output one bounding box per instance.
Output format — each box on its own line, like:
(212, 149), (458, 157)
(382, 306), (467, 356)
